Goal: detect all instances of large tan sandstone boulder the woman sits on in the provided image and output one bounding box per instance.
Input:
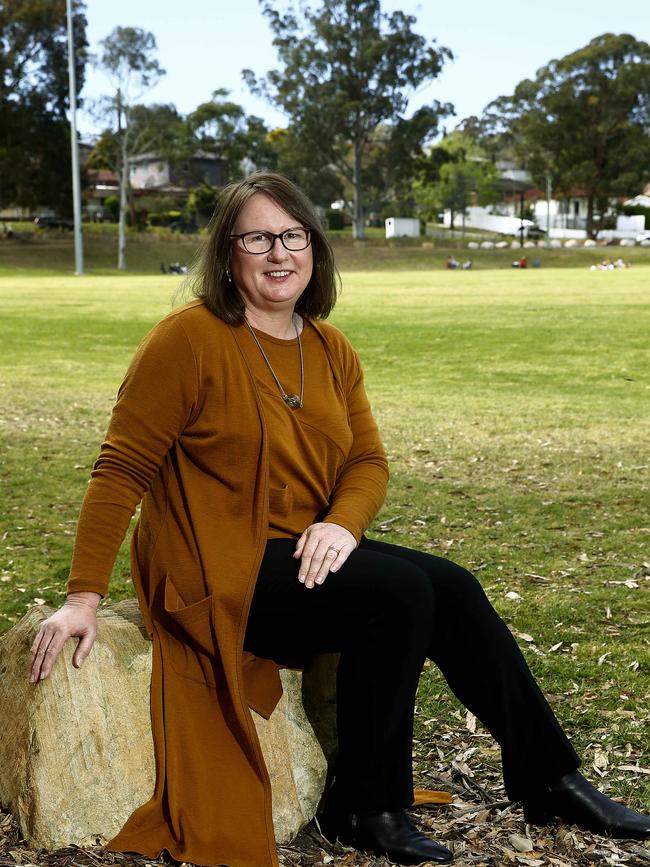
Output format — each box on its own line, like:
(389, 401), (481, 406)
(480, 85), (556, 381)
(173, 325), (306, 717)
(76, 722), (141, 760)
(0, 600), (338, 849)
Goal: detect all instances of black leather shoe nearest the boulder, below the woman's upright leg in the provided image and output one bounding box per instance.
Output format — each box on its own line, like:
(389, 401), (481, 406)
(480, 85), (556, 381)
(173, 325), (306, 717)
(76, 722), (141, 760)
(318, 810), (454, 864)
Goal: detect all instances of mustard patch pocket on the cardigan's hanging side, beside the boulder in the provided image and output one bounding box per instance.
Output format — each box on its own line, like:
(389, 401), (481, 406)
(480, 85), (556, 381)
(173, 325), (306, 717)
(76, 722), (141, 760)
(164, 575), (217, 688)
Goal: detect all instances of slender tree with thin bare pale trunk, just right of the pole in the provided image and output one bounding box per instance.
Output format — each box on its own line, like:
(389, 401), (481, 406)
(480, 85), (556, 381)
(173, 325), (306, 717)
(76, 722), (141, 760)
(100, 27), (165, 271)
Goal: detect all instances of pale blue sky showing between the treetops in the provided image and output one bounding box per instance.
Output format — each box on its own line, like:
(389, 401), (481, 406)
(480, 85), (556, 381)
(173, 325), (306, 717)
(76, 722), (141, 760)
(79, 0), (650, 135)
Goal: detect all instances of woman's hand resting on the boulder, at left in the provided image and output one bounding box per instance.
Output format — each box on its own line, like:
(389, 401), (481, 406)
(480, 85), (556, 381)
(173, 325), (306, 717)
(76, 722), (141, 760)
(28, 591), (102, 683)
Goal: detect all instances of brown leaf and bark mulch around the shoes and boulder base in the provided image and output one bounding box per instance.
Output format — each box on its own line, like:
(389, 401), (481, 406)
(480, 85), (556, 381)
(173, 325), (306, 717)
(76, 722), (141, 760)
(0, 712), (650, 867)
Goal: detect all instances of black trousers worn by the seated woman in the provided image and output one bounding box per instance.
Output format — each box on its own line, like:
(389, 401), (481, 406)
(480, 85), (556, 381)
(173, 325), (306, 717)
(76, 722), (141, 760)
(244, 538), (580, 810)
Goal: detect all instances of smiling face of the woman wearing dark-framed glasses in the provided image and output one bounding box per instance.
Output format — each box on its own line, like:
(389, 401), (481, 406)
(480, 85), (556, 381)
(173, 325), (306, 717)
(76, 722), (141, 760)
(230, 193), (313, 313)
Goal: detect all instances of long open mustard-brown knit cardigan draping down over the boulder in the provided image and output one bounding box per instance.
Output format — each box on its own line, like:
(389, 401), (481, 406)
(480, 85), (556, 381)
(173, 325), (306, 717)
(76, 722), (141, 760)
(68, 301), (388, 867)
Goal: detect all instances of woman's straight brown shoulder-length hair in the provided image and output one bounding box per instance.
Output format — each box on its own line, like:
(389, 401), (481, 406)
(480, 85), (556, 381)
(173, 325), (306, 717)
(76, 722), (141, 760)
(190, 172), (340, 325)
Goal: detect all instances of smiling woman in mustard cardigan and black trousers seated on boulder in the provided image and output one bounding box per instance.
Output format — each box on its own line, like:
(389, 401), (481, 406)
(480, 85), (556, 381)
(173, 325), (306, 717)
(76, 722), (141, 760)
(31, 173), (650, 867)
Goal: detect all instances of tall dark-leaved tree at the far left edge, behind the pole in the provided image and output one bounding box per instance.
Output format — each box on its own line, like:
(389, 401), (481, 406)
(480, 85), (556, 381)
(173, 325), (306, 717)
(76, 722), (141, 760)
(0, 0), (88, 213)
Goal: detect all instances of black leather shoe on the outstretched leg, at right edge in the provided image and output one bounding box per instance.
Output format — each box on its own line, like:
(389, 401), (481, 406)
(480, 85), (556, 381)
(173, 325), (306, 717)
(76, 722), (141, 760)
(523, 771), (650, 840)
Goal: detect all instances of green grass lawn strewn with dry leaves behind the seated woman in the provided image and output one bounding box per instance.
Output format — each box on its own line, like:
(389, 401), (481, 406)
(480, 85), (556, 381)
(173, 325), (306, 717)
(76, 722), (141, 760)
(0, 268), (650, 807)
